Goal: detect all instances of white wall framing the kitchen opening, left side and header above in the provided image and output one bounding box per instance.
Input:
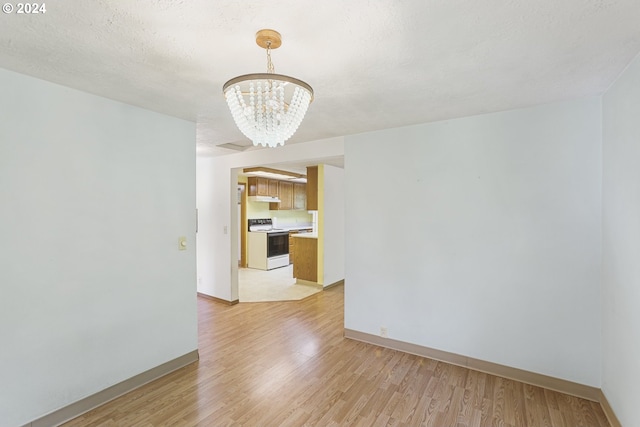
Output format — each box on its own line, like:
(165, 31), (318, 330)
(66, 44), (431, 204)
(196, 138), (344, 301)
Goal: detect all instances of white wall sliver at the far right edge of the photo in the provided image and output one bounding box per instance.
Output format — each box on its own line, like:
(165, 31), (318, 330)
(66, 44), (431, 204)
(602, 51), (640, 426)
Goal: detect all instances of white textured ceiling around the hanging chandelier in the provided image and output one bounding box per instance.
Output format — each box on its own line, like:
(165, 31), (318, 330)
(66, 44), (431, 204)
(0, 0), (640, 154)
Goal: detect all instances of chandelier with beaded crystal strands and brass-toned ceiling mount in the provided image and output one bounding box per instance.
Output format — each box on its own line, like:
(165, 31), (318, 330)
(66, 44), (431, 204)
(222, 30), (313, 147)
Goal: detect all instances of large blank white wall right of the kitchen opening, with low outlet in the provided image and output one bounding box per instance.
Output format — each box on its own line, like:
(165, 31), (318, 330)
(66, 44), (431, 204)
(345, 98), (602, 387)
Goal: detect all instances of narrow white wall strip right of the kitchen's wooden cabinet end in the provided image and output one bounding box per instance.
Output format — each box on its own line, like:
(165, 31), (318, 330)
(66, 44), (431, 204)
(322, 165), (345, 286)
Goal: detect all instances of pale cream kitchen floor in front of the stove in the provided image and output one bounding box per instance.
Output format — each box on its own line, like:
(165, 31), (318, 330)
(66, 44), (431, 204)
(238, 264), (321, 302)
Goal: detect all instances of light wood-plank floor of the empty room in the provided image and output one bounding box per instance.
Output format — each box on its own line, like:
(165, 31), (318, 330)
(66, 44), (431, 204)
(65, 286), (609, 427)
